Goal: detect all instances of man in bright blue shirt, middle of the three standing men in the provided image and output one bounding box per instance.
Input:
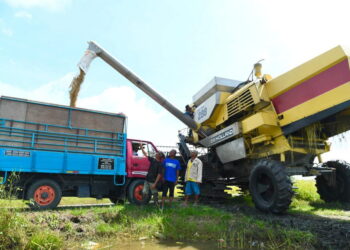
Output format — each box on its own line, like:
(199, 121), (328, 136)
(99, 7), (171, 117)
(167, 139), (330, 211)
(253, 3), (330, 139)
(162, 149), (181, 208)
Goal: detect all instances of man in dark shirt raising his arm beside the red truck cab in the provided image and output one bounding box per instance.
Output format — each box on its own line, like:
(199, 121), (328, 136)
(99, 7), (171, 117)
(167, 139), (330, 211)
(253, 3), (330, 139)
(140, 144), (165, 206)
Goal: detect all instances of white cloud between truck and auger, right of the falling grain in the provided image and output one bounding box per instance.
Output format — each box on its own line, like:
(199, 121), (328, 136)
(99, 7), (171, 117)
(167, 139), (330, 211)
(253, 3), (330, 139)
(77, 86), (180, 145)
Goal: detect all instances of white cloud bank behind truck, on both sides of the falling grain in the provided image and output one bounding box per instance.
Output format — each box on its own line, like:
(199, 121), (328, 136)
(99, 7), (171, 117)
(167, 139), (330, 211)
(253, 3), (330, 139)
(0, 73), (180, 146)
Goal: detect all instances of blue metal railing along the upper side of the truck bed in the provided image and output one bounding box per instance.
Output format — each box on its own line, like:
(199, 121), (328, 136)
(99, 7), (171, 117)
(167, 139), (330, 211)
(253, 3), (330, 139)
(0, 119), (126, 156)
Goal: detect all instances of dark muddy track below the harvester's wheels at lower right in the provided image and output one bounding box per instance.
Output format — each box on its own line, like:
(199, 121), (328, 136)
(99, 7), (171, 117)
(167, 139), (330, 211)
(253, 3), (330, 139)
(210, 204), (350, 249)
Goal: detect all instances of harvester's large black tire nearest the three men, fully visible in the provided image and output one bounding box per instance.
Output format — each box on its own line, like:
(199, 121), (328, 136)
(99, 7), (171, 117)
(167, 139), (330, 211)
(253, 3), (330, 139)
(249, 159), (293, 214)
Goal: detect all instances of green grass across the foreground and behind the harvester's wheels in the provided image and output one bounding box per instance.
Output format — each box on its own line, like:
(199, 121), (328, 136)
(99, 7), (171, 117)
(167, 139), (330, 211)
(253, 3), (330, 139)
(0, 180), (350, 249)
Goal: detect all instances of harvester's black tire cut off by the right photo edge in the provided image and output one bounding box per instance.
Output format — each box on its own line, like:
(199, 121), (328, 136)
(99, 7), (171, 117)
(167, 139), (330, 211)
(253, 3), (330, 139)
(316, 161), (350, 202)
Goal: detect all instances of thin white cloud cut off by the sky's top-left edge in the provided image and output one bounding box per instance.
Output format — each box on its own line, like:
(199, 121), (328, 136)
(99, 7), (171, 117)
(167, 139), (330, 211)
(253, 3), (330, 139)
(4, 0), (71, 11)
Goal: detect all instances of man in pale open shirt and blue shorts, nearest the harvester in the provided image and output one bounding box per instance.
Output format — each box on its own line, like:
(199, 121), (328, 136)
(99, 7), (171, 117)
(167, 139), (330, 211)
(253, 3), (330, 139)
(184, 151), (203, 206)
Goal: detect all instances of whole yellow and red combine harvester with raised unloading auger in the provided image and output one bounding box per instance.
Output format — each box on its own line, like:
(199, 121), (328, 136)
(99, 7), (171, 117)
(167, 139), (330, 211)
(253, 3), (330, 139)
(79, 42), (350, 213)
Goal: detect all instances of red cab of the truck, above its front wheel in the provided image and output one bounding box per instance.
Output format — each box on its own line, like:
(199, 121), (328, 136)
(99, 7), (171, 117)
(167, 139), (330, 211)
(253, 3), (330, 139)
(128, 141), (156, 178)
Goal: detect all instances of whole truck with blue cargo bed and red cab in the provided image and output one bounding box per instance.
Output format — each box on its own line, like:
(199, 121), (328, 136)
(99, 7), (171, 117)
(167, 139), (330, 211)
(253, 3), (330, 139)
(0, 96), (157, 209)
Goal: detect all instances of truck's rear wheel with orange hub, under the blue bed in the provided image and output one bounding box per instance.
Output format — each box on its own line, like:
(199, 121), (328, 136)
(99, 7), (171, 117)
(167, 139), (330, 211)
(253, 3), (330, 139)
(27, 179), (62, 210)
